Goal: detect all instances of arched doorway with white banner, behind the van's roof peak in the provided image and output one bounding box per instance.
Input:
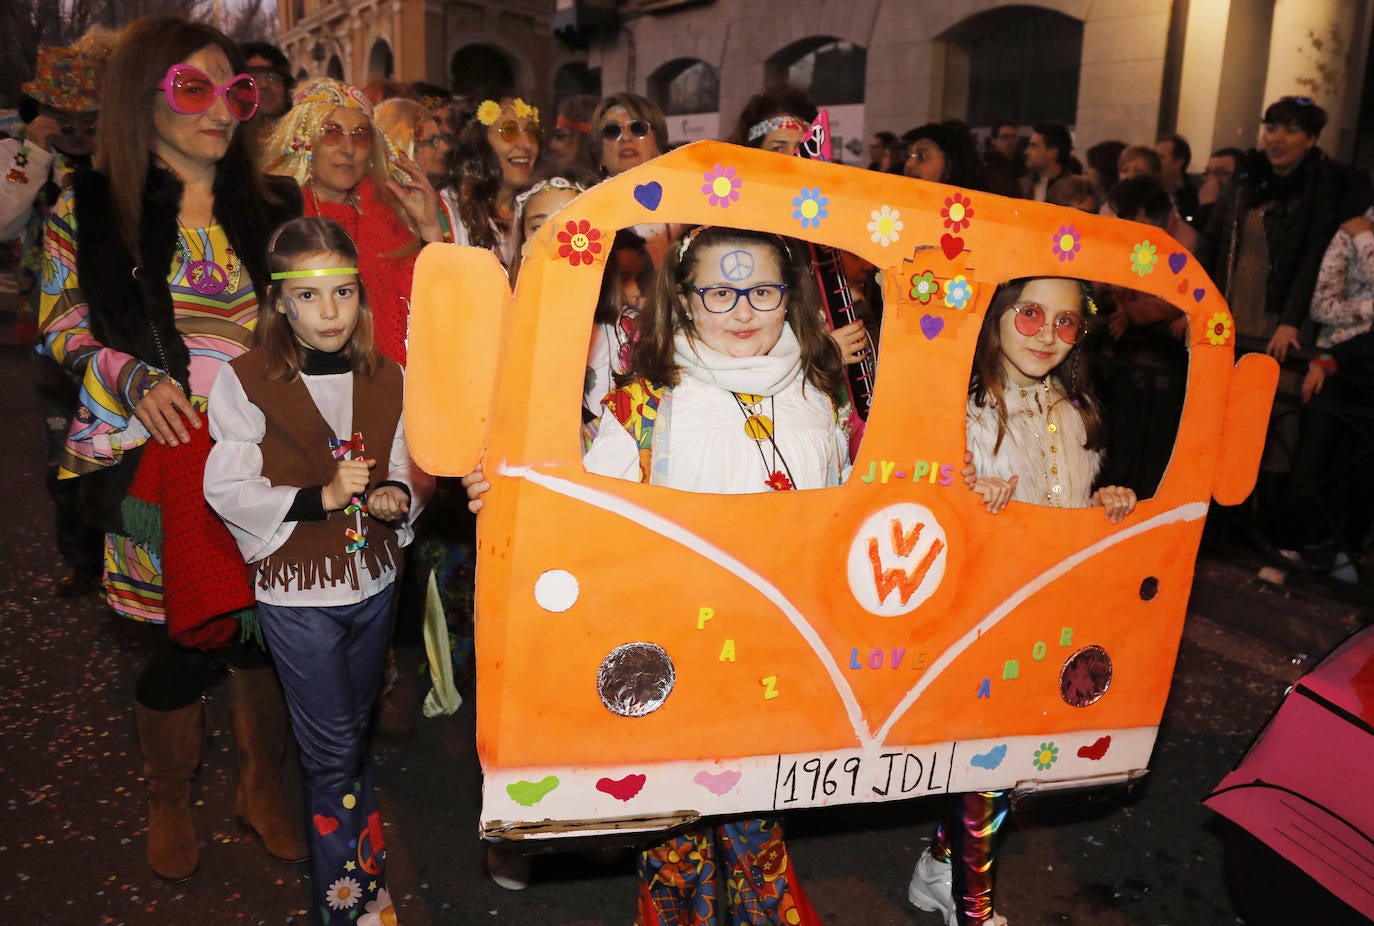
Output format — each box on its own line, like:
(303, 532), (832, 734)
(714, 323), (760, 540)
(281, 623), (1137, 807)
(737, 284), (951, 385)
(764, 36), (868, 163)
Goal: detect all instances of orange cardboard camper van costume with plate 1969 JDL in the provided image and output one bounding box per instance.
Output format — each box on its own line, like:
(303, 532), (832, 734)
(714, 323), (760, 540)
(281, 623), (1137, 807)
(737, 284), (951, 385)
(405, 142), (1278, 838)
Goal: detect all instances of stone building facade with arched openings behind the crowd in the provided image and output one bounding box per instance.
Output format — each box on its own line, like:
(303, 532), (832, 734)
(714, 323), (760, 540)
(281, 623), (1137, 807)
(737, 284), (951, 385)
(280, 0), (1374, 163)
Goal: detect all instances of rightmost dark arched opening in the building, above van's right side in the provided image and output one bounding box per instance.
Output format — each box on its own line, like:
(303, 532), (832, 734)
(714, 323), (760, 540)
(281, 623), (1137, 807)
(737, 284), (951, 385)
(940, 7), (1083, 126)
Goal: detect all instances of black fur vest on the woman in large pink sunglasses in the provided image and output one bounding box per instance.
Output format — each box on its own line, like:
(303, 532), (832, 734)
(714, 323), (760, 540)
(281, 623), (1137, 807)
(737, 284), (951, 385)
(71, 153), (302, 385)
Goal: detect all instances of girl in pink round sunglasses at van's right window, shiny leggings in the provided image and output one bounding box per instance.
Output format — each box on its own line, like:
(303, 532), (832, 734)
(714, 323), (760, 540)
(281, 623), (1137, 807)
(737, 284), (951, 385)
(907, 276), (1135, 926)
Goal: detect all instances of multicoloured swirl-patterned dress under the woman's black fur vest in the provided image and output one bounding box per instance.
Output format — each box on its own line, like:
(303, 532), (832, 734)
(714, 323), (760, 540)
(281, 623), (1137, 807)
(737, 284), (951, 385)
(38, 186), (258, 622)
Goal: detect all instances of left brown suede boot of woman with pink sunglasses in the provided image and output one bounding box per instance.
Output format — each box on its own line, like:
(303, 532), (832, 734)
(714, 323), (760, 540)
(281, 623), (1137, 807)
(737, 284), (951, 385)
(133, 701), (205, 881)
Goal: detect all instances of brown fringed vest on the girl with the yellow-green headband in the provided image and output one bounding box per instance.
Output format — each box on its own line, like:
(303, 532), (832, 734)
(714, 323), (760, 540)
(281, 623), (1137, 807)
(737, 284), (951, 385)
(229, 350), (403, 591)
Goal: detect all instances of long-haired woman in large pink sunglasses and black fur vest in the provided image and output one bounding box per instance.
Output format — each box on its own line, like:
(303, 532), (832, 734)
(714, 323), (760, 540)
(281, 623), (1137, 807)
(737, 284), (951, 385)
(40, 16), (308, 881)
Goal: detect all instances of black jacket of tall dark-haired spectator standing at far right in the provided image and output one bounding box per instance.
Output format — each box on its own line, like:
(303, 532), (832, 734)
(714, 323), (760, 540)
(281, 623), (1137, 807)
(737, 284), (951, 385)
(1197, 147), (1371, 327)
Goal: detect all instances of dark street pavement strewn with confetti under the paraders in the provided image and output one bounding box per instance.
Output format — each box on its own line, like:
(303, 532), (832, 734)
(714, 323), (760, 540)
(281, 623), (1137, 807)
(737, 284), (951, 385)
(0, 265), (1369, 926)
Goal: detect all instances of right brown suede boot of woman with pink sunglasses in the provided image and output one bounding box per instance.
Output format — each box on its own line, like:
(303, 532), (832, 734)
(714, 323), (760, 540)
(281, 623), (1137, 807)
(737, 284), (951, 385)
(229, 669), (311, 861)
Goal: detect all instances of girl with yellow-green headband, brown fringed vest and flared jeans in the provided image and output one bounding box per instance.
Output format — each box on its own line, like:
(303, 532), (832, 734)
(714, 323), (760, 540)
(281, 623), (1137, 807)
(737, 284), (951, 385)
(205, 217), (430, 923)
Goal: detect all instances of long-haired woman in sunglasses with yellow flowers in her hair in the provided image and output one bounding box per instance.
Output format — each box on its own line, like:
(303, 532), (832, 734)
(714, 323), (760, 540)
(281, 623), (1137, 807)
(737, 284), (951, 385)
(453, 93), (540, 272)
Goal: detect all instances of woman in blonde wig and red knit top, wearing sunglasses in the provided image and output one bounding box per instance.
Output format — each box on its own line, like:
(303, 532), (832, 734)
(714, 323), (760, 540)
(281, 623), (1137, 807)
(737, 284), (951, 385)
(265, 77), (451, 365)
